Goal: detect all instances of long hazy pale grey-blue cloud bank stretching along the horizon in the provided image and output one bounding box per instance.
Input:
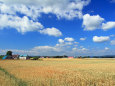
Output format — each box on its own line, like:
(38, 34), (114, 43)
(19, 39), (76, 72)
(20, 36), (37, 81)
(0, 46), (115, 56)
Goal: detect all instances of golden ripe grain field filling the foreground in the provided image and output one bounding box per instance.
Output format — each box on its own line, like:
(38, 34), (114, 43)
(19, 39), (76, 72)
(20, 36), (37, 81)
(0, 58), (115, 86)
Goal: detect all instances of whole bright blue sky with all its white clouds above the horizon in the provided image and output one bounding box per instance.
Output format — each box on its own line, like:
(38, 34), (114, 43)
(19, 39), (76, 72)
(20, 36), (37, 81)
(0, 0), (115, 56)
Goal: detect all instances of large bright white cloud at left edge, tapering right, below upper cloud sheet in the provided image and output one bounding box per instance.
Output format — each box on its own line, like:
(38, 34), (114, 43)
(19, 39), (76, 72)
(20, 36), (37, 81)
(0, 14), (43, 34)
